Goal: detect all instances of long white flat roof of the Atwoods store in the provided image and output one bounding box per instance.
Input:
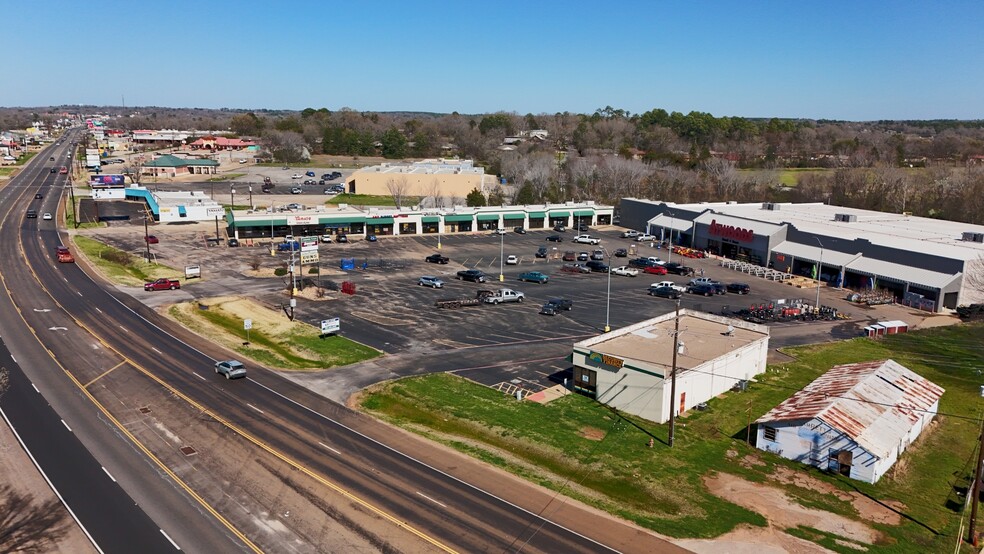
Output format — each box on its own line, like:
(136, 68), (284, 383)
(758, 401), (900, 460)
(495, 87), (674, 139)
(634, 199), (984, 261)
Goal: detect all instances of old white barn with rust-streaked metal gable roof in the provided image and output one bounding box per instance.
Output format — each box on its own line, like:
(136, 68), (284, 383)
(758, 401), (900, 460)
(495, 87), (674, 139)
(755, 360), (943, 483)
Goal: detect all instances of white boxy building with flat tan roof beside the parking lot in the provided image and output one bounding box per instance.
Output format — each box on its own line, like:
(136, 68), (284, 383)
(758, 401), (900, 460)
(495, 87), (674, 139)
(574, 309), (769, 423)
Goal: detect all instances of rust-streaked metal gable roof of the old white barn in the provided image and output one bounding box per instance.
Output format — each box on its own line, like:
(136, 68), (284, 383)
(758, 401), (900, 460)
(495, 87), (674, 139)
(756, 360), (944, 458)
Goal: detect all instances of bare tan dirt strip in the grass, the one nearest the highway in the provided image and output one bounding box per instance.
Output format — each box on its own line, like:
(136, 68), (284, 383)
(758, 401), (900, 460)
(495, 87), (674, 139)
(704, 473), (884, 544)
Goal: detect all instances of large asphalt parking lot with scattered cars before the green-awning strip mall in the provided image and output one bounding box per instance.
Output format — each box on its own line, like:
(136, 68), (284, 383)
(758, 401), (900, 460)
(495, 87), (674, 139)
(80, 217), (928, 399)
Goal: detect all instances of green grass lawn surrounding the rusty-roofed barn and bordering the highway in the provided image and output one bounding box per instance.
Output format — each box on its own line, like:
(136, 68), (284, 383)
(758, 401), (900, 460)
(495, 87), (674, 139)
(362, 325), (984, 553)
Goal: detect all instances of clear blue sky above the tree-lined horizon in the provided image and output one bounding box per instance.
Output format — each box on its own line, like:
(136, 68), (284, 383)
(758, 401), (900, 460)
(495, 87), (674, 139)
(7, 0), (984, 121)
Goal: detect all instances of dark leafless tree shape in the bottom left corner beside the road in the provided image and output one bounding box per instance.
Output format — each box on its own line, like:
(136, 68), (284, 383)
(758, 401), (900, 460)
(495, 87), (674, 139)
(0, 484), (69, 552)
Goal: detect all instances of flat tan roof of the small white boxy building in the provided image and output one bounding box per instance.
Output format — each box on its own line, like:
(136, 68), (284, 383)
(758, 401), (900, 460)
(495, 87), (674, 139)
(574, 309), (769, 374)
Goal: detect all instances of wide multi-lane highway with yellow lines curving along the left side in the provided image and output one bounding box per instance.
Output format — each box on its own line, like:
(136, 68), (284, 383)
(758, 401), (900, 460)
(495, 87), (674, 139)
(0, 134), (681, 552)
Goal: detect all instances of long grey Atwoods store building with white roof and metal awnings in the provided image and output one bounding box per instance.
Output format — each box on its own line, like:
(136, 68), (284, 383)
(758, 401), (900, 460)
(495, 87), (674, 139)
(621, 198), (984, 311)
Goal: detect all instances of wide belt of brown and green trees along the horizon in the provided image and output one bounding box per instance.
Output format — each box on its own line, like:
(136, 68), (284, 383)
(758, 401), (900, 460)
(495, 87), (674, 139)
(0, 106), (984, 224)
